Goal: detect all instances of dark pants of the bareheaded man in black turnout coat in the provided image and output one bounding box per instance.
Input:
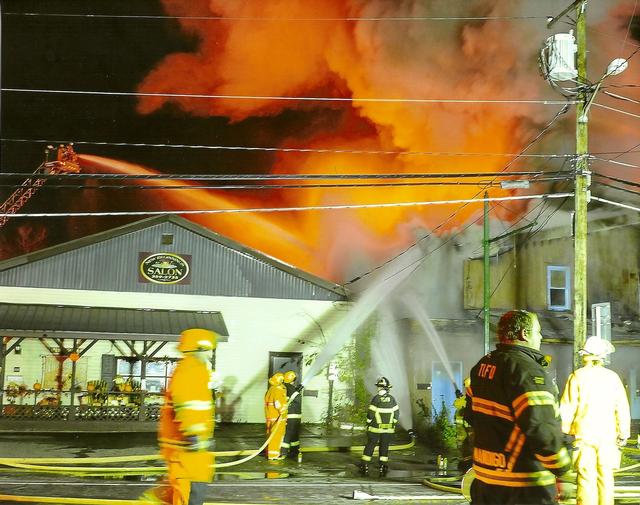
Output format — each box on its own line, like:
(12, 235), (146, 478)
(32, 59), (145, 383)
(471, 479), (558, 505)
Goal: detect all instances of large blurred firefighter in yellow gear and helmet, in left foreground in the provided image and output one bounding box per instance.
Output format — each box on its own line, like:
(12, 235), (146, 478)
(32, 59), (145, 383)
(154, 328), (217, 505)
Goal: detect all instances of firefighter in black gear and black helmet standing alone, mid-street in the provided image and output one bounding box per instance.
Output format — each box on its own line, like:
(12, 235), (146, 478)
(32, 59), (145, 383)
(360, 377), (400, 477)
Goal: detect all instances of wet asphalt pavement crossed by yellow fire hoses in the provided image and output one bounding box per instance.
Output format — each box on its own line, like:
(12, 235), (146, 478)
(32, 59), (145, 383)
(0, 424), (466, 505)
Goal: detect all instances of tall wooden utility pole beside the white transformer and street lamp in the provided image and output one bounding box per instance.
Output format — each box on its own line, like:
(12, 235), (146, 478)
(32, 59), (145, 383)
(573, 1), (591, 369)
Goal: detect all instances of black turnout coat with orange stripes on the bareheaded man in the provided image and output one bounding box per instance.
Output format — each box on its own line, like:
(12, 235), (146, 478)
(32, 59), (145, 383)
(465, 344), (571, 487)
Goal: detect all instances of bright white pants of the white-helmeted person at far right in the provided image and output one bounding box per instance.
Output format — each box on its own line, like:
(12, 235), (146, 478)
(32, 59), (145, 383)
(574, 442), (620, 505)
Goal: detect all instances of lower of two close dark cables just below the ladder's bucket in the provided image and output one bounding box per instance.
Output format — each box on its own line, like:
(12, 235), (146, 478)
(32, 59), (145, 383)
(0, 177), (567, 191)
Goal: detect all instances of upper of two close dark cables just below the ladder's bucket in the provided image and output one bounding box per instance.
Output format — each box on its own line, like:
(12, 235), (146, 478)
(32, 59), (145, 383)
(0, 170), (569, 181)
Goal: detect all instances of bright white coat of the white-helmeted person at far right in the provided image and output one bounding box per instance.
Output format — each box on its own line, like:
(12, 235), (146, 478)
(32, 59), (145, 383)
(560, 362), (631, 445)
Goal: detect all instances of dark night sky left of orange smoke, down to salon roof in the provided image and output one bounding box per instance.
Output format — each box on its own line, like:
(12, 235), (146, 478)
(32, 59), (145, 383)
(0, 0), (350, 257)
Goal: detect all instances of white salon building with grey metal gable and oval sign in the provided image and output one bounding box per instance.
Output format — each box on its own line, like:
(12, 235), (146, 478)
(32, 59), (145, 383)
(0, 216), (347, 422)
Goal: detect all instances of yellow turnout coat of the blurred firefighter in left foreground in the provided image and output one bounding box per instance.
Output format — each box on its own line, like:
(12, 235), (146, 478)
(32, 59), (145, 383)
(158, 354), (214, 450)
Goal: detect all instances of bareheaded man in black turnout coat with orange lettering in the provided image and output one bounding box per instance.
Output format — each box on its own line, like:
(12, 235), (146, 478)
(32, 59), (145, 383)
(465, 310), (571, 505)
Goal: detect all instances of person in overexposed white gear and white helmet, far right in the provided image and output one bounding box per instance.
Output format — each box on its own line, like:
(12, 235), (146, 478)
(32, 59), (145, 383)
(560, 337), (631, 505)
